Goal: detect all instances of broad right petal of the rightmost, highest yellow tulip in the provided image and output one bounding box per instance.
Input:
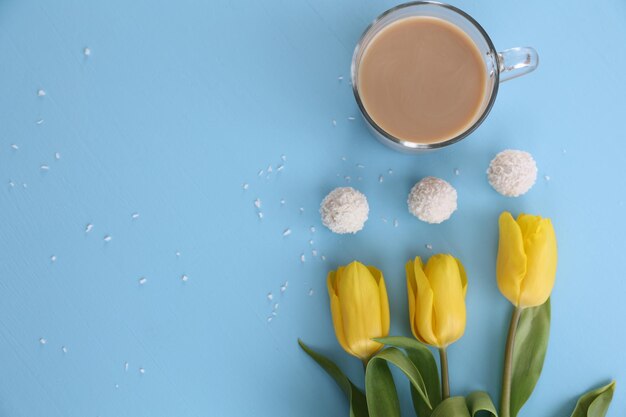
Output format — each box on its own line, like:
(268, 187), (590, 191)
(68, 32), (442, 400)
(517, 214), (558, 307)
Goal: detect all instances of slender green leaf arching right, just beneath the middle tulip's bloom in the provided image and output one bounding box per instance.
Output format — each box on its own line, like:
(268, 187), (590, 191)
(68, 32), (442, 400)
(375, 336), (441, 417)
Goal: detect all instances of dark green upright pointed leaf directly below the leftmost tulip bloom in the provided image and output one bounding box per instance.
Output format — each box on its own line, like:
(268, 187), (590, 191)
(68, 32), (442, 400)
(365, 351), (400, 417)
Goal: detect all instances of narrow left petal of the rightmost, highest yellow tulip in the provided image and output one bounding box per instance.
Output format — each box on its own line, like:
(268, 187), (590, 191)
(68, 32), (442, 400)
(496, 211), (526, 306)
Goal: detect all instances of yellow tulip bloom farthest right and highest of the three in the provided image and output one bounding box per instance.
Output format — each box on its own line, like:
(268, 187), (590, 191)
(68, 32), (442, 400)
(496, 212), (557, 308)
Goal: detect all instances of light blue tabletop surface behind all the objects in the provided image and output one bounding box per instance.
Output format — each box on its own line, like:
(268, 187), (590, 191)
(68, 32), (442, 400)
(0, 0), (626, 417)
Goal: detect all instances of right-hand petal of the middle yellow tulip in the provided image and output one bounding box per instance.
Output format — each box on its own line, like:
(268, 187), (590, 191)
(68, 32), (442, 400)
(425, 254), (466, 347)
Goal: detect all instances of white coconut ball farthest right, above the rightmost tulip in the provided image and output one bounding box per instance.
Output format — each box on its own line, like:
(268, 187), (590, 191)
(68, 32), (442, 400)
(487, 149), (537, 197)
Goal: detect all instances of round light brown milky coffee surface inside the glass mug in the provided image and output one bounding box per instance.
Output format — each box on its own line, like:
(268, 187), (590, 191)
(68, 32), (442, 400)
(358, 17), (487, 143)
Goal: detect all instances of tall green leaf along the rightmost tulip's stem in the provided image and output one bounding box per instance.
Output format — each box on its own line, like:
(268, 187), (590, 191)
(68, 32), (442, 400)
(510, 299), (550, 417)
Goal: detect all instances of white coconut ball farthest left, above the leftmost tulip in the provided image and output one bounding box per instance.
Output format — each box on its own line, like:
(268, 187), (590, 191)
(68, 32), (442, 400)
(320, 187), (370, 234)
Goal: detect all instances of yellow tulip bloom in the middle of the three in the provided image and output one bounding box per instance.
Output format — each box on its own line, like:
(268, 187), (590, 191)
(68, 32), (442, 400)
(406, 254), (467, 348)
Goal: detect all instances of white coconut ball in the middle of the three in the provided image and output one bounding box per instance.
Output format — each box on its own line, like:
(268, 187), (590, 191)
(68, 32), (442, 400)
(407, 177), (457, 223)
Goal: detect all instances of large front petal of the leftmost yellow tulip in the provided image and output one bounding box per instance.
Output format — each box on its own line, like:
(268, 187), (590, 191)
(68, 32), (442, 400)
(337, 262), (383, 359)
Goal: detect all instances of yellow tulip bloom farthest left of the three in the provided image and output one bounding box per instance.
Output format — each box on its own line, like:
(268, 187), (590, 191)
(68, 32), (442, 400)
(327, 261), (389, 361)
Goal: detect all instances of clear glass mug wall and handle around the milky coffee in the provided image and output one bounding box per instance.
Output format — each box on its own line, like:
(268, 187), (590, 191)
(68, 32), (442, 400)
(351, 1), (539, 153)
